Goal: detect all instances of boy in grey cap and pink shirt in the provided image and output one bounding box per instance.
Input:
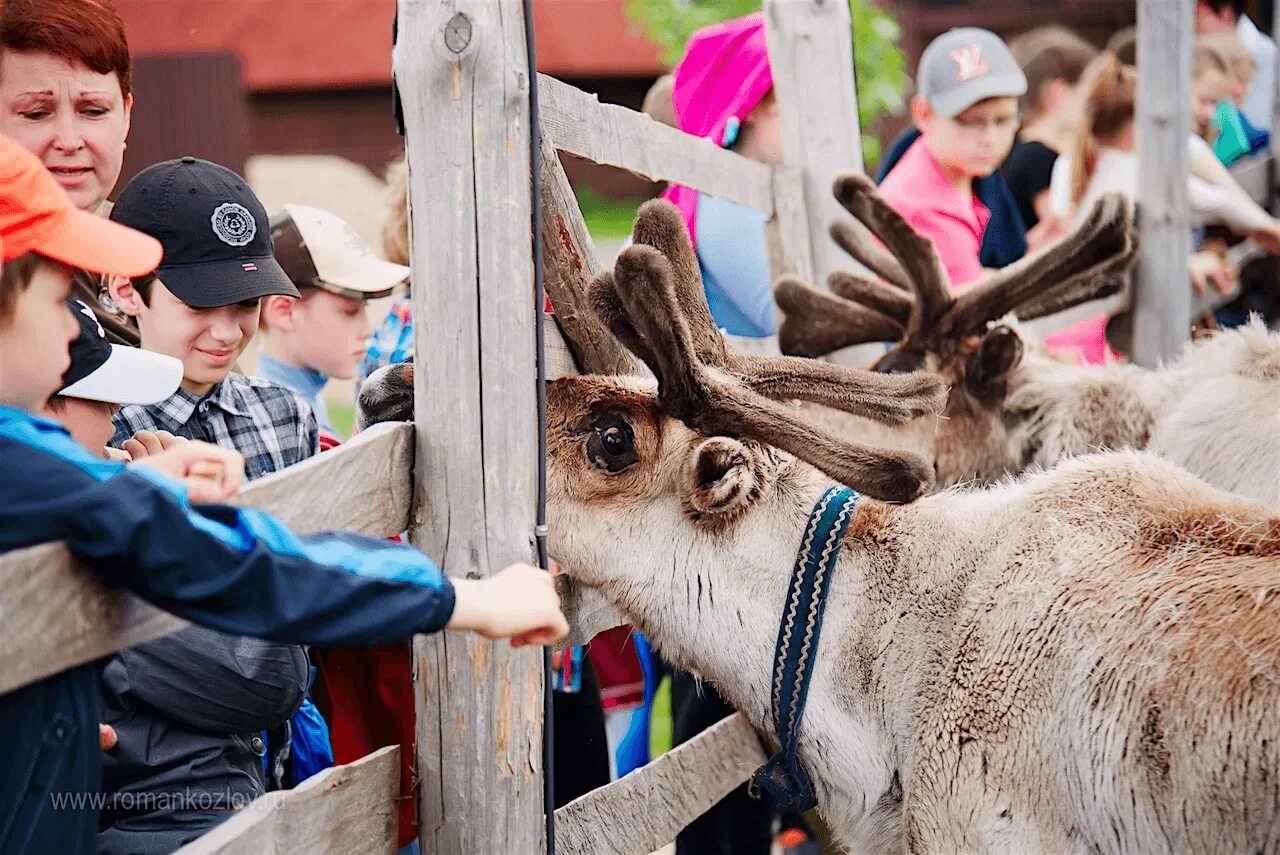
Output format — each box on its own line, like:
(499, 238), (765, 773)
(881, 27), (1027, 285)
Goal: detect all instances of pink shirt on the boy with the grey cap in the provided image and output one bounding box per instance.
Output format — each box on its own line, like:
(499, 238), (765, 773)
(879, 137), (991, 285)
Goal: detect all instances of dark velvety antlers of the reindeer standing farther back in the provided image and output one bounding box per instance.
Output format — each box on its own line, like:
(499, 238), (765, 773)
(776, 173), (1137, 356)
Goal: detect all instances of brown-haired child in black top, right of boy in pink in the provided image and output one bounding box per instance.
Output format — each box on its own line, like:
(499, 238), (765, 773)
(1000, 24), (1098, 250)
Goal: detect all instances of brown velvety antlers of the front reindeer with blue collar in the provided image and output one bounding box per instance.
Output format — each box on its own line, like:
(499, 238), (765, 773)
(590, 201), (945, 502)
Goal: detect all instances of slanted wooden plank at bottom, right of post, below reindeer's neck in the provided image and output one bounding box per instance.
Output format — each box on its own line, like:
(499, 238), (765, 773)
(556, 713), (768, 855)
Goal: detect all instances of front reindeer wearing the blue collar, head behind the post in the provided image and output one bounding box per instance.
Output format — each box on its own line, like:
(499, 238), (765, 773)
(369, 202), (1280, 854)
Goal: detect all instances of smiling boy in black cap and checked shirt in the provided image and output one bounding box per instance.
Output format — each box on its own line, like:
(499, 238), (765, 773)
(110, 157), (317, 480)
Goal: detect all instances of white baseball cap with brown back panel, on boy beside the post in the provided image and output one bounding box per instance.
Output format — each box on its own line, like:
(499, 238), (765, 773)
(271, 204), (410, 300)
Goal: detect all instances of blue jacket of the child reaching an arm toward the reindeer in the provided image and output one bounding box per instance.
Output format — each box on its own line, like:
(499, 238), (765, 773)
(0, 407), (453, 855)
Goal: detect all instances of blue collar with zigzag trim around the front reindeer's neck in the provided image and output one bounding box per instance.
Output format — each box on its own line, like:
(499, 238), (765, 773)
(751, 485), (861, 813)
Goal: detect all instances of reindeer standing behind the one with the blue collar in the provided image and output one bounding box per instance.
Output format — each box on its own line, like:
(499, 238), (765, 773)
(776, 174), (1280, 506)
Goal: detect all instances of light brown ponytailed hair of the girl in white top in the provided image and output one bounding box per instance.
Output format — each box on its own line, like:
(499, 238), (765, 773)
(1071, 52), (1138, 205)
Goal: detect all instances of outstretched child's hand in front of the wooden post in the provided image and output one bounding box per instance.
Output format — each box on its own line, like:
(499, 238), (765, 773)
(448, 564), (568, 648)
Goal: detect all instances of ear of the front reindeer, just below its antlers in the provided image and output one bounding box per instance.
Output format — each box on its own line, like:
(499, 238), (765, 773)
(681, 436), (768, 529)
